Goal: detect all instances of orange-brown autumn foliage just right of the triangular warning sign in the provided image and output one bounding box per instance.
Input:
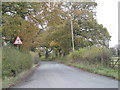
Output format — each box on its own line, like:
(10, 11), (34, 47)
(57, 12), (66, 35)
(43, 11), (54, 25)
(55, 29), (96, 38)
(13, 17), (38, 50)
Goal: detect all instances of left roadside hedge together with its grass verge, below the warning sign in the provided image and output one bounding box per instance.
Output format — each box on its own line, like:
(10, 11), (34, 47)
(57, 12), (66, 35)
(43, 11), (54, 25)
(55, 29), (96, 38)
(2, 47), (40, 88)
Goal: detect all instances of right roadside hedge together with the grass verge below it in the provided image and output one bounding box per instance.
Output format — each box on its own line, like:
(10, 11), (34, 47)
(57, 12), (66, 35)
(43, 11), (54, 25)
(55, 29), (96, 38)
(55, 47), (120, 80)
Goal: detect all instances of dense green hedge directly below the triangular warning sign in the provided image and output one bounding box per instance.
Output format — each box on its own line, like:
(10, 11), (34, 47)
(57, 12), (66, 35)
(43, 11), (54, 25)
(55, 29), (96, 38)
(2, 47), (32, 77)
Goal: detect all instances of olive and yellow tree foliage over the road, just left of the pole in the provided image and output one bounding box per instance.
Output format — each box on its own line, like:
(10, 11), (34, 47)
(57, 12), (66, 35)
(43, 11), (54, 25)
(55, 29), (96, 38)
(36, 23), (71, 55)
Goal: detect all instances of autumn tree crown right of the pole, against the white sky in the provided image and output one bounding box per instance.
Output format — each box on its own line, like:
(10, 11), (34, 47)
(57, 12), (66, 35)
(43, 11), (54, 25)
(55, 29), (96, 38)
(71, 2), (110, 47)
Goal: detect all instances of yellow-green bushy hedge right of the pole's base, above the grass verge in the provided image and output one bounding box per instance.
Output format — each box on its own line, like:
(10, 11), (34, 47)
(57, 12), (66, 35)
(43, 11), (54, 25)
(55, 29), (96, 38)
(71, 46), (111, 65)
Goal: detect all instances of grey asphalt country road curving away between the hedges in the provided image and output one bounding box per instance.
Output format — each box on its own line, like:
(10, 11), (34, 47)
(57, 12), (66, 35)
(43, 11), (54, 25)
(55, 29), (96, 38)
(12, 62), (118, 88)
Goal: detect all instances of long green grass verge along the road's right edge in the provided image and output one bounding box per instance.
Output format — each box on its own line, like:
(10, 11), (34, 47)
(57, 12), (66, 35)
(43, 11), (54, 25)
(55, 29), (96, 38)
(55, 59), (120, 80)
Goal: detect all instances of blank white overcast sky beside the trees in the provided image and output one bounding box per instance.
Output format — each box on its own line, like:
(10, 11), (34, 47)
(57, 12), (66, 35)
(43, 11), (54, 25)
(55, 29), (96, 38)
(95, 0), (120, 47)
